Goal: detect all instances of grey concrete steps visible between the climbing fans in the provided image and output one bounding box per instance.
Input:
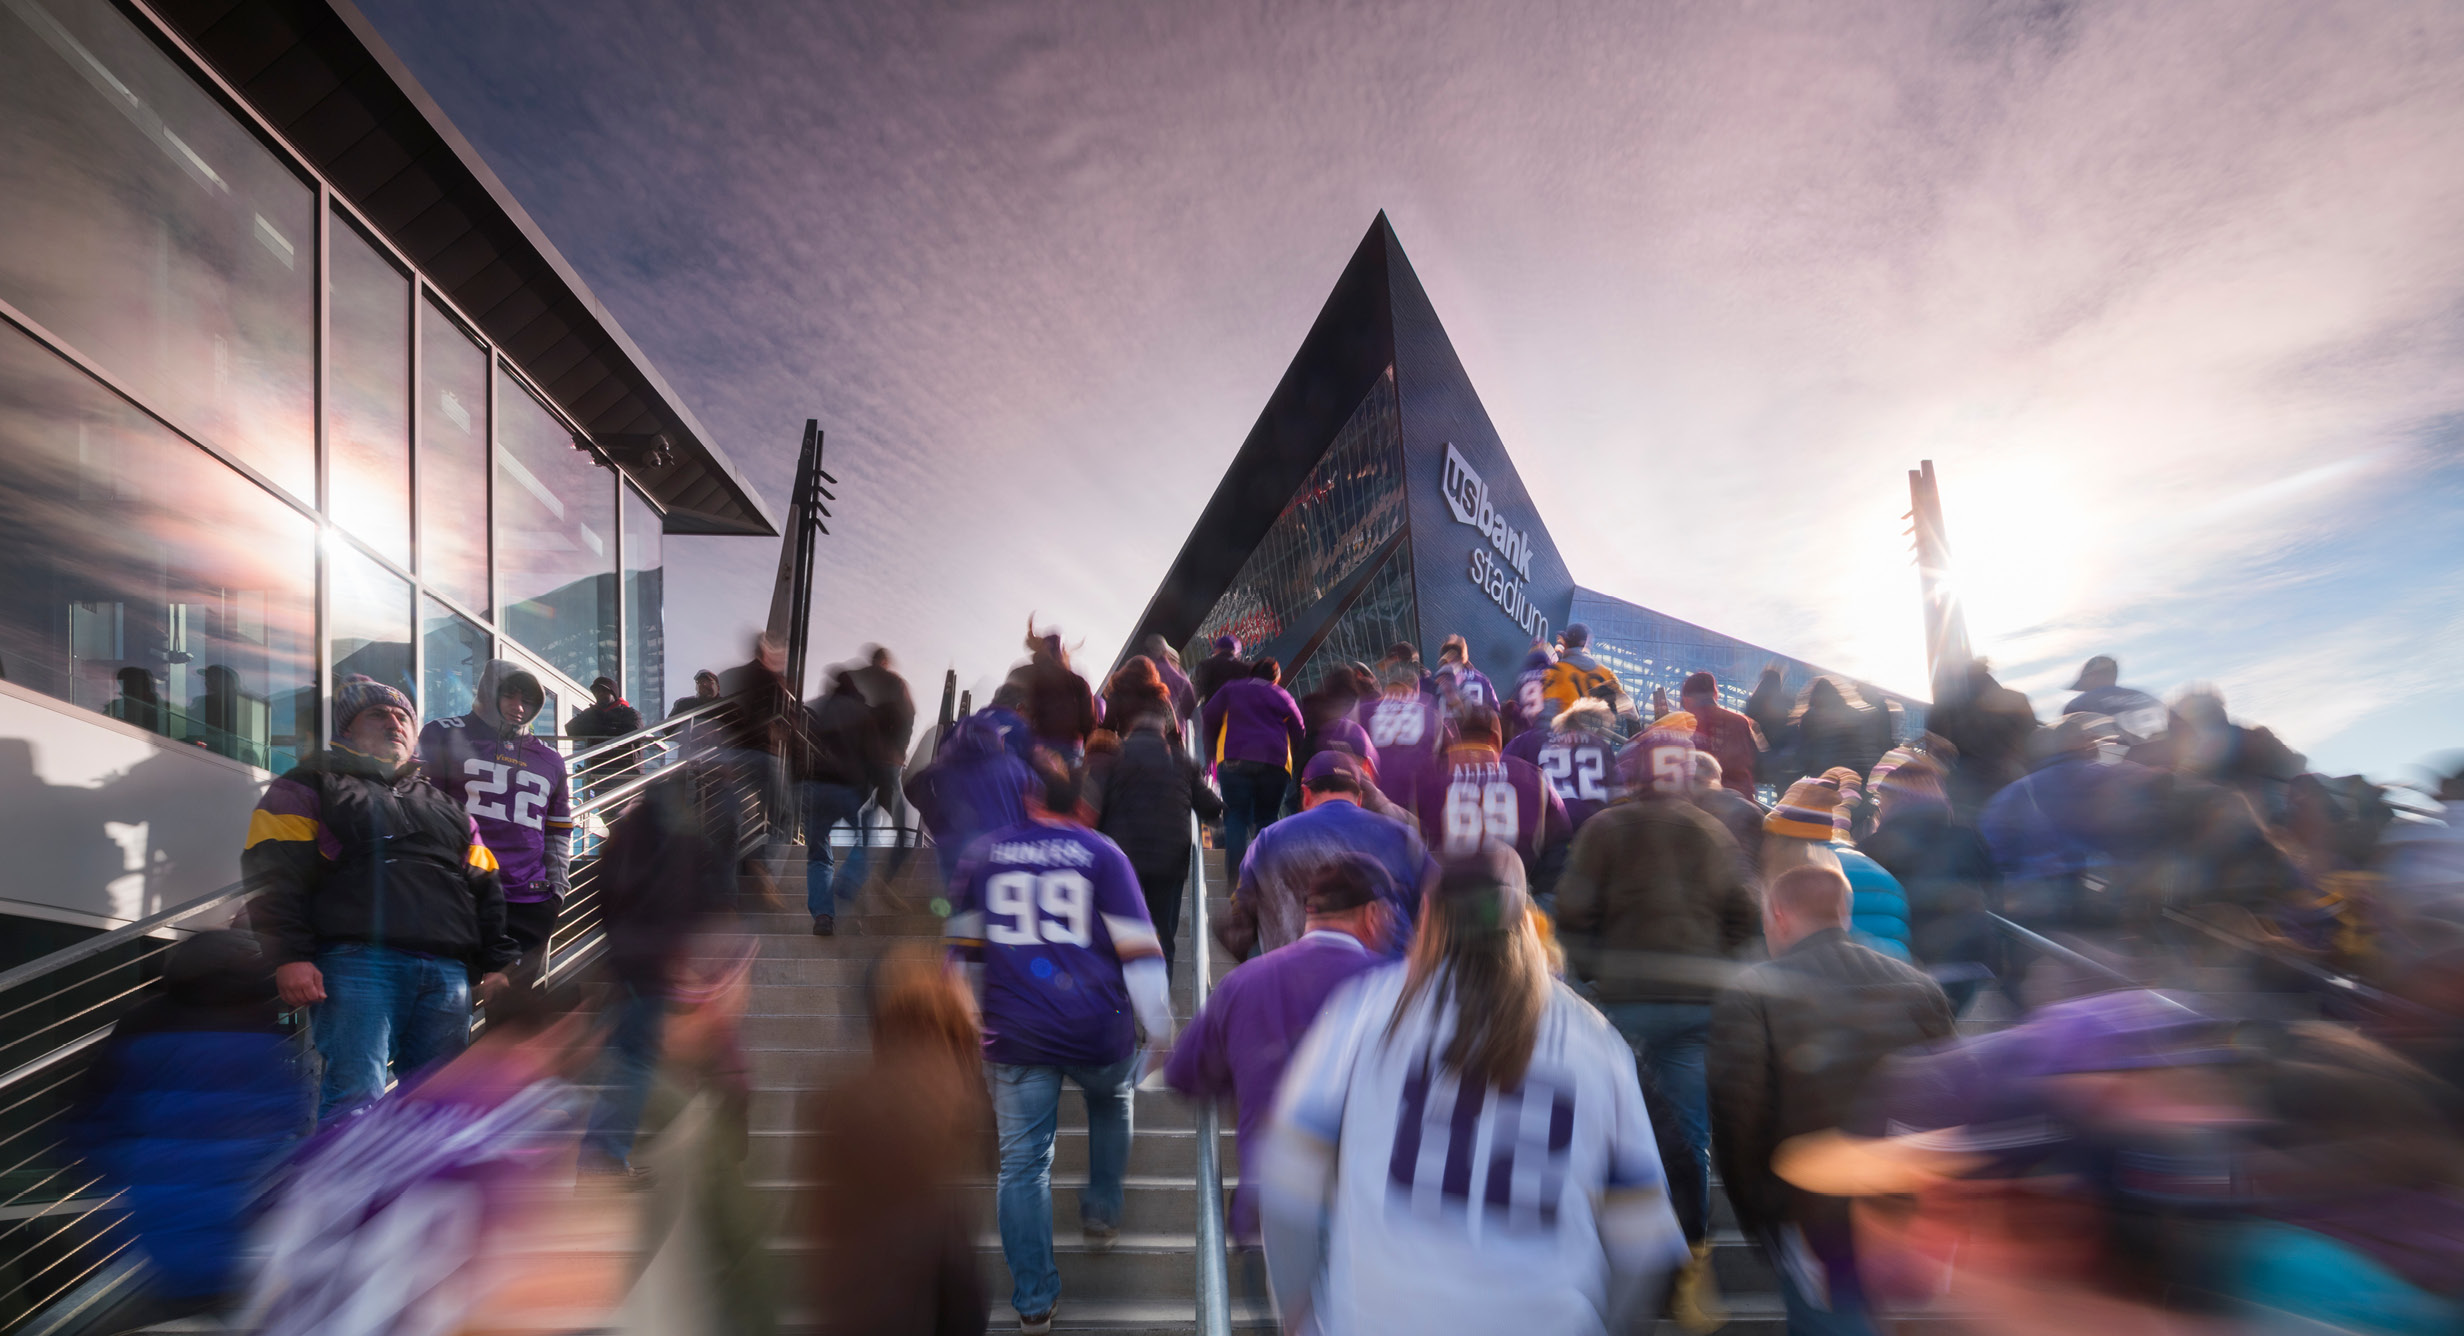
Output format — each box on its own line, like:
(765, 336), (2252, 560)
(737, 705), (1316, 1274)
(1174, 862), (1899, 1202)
(744, 848), (1784, 1336)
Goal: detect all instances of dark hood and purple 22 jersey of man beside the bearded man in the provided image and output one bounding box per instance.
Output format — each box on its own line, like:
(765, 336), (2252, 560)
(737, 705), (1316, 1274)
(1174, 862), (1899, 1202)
(419, 658), (574, 905)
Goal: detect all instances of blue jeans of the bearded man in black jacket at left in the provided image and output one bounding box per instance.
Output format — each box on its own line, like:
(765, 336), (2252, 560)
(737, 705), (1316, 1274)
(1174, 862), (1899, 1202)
(310, 942), (471, 1122)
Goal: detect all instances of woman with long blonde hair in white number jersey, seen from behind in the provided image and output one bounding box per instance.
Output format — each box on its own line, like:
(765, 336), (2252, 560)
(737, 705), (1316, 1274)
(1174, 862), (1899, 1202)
(1259, 845), (1688, 1336)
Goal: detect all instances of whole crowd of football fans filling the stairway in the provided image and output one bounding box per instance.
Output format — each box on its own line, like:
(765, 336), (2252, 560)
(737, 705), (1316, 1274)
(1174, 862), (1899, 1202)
(57, 624), (2464, 1336)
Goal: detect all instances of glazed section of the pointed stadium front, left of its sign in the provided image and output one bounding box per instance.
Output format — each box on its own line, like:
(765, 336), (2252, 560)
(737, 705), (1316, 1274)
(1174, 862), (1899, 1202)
(1180, 367), (1404, 670)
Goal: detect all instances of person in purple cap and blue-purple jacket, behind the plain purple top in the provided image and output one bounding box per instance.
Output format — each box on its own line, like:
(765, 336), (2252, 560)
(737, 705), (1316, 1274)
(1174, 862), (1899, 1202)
(1215, 752), (1437, 959)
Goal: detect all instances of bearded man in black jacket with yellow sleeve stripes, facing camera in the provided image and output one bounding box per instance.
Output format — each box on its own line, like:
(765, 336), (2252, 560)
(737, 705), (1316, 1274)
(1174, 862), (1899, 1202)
(239, 675), (522, 1122)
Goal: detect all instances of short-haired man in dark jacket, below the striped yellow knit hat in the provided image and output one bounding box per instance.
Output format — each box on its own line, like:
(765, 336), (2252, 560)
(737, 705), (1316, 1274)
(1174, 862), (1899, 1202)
(1708, 865), (1951, 1336)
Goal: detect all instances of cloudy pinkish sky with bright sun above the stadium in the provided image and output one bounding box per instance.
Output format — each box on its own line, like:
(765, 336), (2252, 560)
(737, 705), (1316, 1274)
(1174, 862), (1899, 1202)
(360, 0), (2464, 779)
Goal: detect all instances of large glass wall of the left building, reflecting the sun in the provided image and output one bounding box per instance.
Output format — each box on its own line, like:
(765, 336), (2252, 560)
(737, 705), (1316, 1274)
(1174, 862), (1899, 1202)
(0, 0), (665, 772)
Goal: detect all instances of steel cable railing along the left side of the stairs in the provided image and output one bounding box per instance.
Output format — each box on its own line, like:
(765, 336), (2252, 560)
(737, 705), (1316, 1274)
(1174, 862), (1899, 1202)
(0, 703), (776, 1329)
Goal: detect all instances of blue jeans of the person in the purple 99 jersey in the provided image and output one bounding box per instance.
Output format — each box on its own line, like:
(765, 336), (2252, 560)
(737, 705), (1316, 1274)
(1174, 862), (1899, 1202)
(988, 1053), (1138, 1314)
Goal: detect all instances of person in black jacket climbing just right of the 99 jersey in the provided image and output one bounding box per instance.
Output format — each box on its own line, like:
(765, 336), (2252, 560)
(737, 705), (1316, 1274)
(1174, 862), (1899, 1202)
(1087, 704), (1225, 976)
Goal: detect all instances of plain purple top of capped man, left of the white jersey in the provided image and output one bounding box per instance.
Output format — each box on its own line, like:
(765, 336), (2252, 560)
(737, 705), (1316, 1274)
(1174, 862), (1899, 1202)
(1163, 932), (1385, 1242)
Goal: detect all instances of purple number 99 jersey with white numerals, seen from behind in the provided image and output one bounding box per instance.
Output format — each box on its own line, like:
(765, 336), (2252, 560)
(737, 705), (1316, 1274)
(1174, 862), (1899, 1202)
(941, 821), (1163, 1067)
